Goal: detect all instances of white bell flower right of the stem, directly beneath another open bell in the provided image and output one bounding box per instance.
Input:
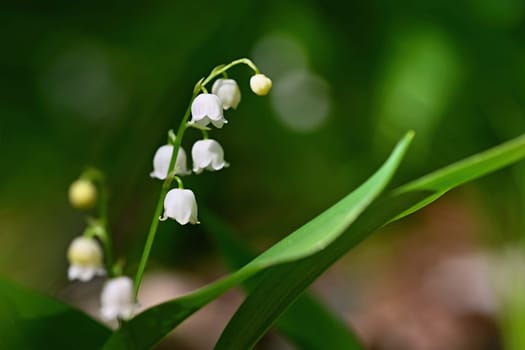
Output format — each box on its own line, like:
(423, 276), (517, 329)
(191, 139), (229, 174)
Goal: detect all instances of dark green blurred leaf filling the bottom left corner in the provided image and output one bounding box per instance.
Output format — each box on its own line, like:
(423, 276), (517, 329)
(0, 279), (111, 350)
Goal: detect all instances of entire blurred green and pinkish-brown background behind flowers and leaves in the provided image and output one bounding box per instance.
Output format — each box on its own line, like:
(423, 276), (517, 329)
(0, 0), (525, 350)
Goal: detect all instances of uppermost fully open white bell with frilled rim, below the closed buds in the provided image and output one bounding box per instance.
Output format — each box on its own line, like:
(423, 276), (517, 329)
(190, 94), (228, 128)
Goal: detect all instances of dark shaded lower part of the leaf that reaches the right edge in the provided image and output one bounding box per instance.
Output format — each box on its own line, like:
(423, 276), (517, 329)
(215, 192), (429, 350)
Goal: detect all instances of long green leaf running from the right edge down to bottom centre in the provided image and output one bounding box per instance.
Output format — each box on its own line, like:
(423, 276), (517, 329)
(216, 136), (525, 350)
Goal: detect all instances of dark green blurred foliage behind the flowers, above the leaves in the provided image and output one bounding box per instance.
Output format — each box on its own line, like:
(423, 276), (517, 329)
(0, 0), (525, 322)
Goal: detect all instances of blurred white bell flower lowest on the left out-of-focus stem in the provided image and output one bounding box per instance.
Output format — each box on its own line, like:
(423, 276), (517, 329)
(100, 276), (139, 321)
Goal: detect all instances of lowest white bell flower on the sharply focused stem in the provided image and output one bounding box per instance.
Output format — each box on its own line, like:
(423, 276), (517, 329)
(160, 188), (199, 225)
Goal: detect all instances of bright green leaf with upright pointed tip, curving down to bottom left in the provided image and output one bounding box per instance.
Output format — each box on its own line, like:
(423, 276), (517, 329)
(104, 132), (414, 349)
